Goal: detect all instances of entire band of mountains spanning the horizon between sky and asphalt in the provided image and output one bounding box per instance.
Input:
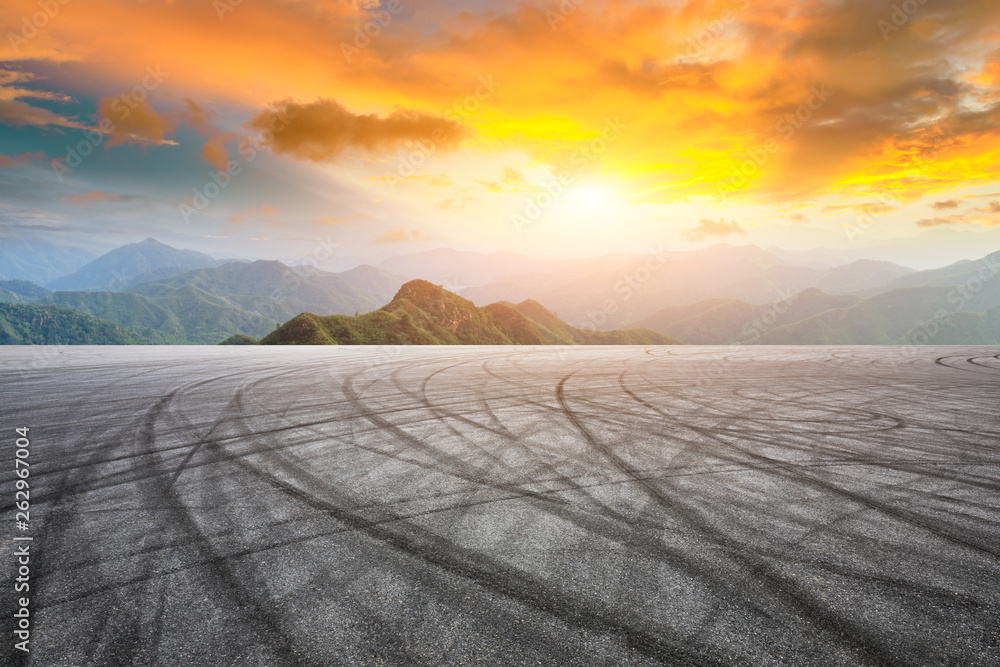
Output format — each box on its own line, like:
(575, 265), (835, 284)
(0, 239), (1000, 344)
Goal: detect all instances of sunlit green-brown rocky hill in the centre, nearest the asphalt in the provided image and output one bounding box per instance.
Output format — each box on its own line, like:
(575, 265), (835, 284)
(261, 280), (677, 345)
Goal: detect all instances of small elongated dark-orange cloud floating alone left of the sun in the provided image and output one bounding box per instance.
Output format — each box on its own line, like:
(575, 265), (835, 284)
(251, 99), (468, 162)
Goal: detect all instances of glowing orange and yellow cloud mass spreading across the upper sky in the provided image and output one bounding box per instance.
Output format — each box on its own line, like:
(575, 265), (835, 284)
(0, 0), (1000, 214)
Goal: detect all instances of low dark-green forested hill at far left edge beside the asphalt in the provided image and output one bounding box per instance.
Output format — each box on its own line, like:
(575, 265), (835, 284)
(0, 303), (153, 345)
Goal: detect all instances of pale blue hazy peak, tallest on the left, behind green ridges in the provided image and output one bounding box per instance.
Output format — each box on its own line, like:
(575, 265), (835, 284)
(48, 239), (219, 292)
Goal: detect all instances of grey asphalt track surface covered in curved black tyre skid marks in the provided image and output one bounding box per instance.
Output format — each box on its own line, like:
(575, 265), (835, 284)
(0, 346), (1000, 666)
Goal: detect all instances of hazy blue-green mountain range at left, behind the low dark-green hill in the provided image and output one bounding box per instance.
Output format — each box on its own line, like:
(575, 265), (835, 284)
(0, 239), (404, 345)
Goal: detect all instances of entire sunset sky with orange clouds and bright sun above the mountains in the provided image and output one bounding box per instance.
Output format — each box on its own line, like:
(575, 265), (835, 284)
(0, 0), (1000, 270)
